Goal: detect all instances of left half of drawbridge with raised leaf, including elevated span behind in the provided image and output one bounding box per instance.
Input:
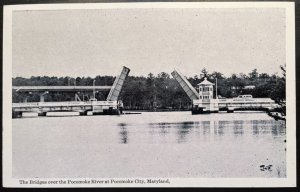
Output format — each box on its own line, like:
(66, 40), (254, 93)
(12, 67), (130, 118)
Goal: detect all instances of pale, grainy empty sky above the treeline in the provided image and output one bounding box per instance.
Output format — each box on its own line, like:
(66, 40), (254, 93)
(12, 8), (286, 77)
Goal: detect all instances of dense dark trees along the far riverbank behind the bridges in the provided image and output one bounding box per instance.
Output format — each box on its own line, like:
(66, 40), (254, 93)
(13, 66), (286, 110)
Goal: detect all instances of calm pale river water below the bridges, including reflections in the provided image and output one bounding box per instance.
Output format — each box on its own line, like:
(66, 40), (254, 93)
(12, 112), (286, 178)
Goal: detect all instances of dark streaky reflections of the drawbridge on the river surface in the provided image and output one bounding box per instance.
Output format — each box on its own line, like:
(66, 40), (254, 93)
(118, 120), (286, 144)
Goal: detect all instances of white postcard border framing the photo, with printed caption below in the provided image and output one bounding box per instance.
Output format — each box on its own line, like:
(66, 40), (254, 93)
(2, 2), (296, 188)
